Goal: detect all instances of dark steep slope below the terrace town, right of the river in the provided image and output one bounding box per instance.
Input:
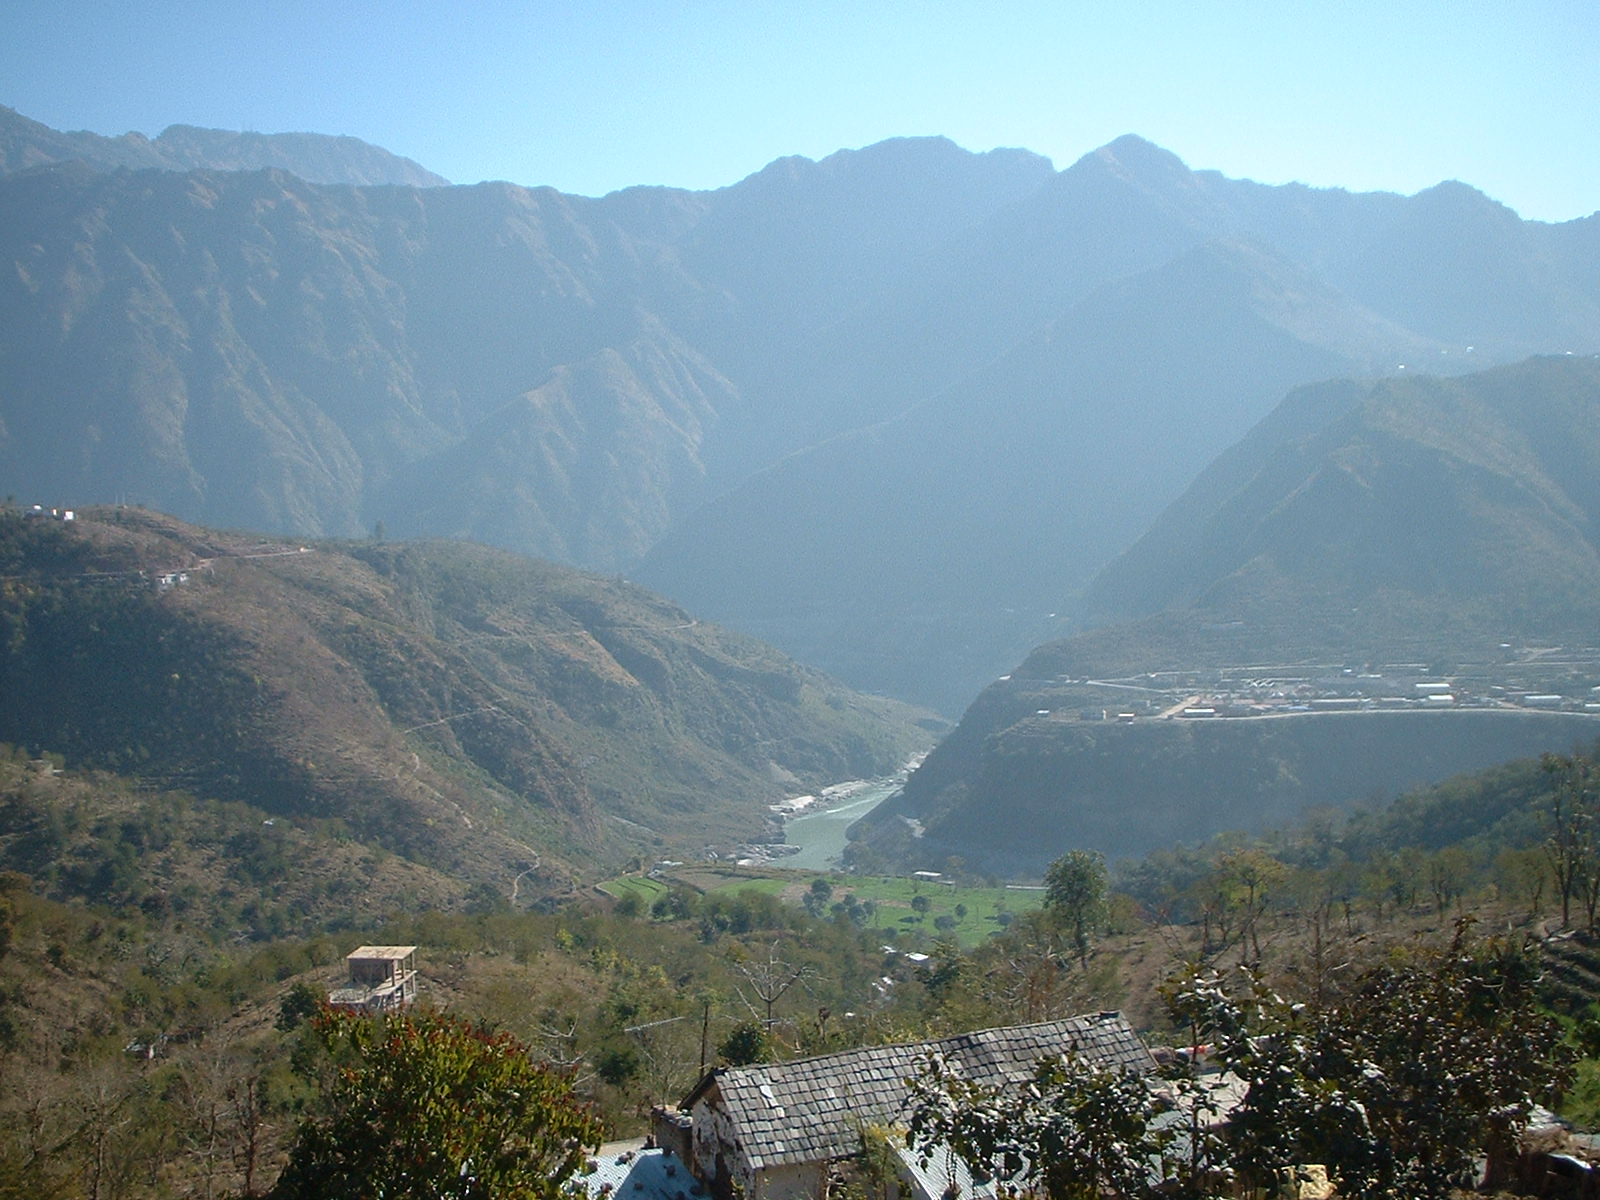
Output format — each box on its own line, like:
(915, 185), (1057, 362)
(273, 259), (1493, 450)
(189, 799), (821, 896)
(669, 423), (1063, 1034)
(851, 710), (1600, 878)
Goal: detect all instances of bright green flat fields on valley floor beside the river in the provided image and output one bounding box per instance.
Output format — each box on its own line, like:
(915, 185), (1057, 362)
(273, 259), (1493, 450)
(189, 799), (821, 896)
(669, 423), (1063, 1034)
(600, 867), (1043, 947)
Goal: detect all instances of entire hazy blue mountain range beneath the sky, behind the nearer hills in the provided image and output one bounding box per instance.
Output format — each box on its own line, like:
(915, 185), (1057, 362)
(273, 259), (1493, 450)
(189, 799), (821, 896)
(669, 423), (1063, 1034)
(0, 105), (1600, 712)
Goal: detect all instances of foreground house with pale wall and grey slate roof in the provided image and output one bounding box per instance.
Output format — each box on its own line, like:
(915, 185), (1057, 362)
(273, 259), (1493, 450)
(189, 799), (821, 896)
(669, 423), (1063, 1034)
(682, 1013), (1155, 1200)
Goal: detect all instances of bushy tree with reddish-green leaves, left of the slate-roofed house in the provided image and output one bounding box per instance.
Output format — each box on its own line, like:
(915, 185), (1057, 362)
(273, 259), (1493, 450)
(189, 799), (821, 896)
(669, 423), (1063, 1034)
(272, 1010), (602, 1200)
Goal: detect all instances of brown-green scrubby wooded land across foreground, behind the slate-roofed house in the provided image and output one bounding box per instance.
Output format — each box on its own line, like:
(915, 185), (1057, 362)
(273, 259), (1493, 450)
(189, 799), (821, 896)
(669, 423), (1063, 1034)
(9, 758), (1600, 1197)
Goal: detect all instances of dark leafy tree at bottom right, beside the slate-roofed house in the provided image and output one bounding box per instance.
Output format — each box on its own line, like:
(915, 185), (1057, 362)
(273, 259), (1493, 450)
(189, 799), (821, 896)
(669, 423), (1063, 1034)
(1173, 925), (1571, 1200)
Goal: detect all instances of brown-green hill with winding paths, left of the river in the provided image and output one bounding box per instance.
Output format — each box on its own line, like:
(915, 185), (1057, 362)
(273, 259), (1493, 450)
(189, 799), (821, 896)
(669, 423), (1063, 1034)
(0, 507), (931, 883)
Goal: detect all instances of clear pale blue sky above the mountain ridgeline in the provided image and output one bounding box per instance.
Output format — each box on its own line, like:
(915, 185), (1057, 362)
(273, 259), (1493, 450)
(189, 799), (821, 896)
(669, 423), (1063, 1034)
(0, 0), (1600, 221)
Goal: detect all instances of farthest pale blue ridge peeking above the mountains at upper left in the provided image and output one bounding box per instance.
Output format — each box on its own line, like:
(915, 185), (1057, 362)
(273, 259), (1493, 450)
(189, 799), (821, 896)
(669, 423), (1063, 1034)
(0, 106), (450, 187)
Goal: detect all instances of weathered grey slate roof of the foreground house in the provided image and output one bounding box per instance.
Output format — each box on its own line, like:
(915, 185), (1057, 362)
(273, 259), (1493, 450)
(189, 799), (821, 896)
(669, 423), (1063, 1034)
(683, 1013), (1155, 1170)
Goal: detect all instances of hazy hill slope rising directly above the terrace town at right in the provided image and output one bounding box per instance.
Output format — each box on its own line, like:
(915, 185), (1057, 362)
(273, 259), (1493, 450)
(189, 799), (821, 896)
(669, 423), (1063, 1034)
(1086, 357), (1600, 634)
